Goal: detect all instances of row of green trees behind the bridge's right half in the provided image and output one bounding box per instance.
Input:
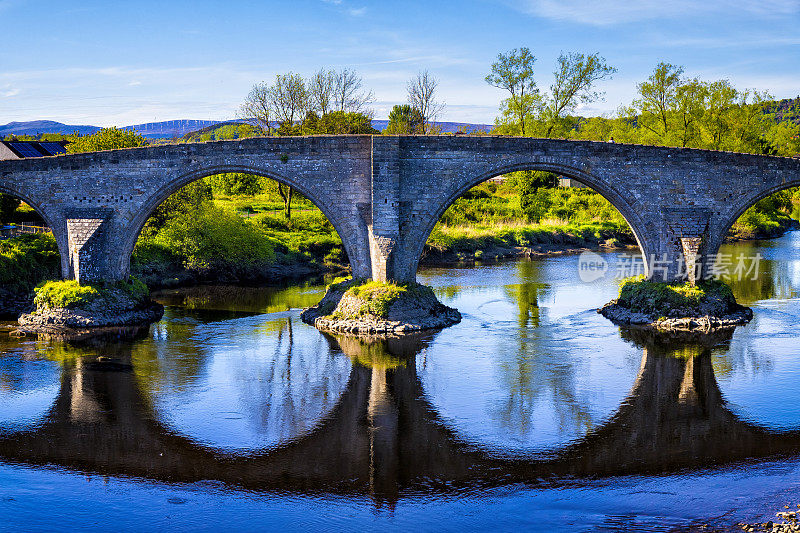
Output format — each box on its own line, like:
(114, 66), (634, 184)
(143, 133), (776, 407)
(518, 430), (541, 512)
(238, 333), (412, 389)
(486, 47), (800, 156)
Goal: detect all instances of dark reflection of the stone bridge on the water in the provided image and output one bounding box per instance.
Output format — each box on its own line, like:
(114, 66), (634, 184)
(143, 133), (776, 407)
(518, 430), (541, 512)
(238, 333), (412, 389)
(0, 328), (800, 504)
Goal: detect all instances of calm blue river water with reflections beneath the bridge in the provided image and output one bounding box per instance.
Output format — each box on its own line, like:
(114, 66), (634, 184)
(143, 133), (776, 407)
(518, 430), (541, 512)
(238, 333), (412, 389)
(0, 233), (800, 531)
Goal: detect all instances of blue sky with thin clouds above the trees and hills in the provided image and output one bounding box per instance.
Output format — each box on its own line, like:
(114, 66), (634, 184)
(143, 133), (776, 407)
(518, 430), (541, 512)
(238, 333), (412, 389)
(0, 0), (800, 126)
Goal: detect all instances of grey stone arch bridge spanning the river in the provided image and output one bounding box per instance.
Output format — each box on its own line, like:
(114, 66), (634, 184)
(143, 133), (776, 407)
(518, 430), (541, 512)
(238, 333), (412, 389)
(0, 136), (800, 281)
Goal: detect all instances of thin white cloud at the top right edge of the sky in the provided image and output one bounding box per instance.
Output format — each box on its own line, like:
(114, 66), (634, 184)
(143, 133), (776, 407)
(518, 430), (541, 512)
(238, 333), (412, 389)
(507, 0), (800, 26)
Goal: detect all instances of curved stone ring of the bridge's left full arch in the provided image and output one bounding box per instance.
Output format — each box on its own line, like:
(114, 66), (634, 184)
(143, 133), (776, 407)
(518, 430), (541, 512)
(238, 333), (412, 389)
(113, 165), (358, 278)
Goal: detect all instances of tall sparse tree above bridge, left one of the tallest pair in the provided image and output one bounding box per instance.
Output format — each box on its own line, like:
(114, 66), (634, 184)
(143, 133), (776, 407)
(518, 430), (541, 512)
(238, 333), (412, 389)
(485, 47), (540, 135)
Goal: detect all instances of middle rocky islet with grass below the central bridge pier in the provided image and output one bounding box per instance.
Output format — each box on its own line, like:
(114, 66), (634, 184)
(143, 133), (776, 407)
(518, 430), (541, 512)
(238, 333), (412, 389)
(300, 279), (461, 336)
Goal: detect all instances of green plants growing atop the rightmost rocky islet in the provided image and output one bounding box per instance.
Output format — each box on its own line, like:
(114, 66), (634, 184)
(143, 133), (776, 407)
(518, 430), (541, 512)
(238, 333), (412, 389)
(617, 276), (736, 313)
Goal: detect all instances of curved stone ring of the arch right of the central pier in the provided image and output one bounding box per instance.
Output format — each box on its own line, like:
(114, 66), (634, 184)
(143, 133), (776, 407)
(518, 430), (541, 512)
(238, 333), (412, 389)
(412, 159), (656, 272)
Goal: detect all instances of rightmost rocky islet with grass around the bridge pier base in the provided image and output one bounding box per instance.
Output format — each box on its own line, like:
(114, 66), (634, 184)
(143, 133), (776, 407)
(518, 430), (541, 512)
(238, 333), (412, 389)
(597, 276), (753, 333)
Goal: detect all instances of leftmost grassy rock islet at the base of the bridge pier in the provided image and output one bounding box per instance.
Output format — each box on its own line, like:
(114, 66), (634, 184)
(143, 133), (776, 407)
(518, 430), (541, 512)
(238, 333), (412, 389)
(14, 277), (164, 335)
